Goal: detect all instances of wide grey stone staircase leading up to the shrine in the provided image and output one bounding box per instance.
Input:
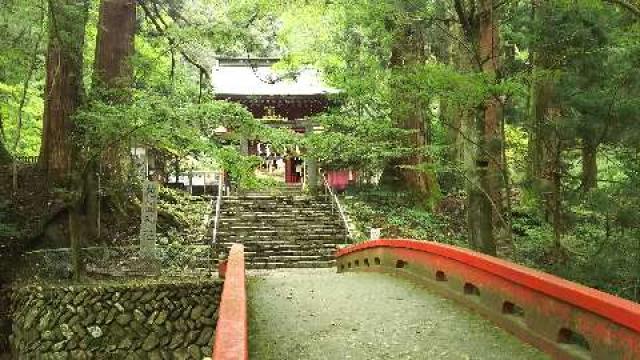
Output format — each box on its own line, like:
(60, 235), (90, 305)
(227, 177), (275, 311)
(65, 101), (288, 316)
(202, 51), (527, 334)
(216, 190), (347, 269)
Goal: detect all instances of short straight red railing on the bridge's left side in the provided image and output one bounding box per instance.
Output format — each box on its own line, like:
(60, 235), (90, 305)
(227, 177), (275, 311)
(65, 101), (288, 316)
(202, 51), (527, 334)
(213, 244), (249, 360)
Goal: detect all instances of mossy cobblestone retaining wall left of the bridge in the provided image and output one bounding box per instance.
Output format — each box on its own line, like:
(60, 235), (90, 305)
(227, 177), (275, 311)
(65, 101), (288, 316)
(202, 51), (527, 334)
(10, 280), (222, 360)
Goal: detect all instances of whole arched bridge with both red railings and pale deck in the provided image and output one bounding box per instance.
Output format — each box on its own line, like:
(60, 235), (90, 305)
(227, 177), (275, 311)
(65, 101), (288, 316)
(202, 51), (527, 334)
(214, 240), (640, 360)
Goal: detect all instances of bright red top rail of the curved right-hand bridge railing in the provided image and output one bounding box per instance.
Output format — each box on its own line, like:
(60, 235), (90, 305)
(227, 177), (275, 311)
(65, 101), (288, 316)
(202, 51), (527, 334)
(336, 240), (640, 332)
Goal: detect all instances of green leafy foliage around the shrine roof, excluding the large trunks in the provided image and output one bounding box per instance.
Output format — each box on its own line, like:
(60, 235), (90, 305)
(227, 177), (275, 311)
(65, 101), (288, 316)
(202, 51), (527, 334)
(0, 0), (640, 299)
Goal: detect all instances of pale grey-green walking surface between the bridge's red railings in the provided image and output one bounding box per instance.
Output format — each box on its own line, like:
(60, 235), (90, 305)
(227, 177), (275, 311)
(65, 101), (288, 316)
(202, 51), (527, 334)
(249, 269), (548, 360)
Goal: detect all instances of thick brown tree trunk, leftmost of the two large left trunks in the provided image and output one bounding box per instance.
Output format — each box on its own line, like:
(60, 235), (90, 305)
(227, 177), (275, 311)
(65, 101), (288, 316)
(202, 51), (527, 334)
(40, 0), (89, 181)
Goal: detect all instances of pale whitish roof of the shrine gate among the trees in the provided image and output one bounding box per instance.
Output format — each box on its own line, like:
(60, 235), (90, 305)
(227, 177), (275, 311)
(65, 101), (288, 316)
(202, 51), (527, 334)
(212, 58), (339, 97)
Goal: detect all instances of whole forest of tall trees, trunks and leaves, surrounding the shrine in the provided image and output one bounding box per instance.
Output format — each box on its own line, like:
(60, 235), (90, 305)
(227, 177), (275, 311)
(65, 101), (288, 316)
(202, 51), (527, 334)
(0, 0), (640, 301)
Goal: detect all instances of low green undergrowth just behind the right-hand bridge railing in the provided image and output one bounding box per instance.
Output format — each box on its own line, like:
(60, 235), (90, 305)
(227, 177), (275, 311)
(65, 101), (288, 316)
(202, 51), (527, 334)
(344, 187), (640, 301)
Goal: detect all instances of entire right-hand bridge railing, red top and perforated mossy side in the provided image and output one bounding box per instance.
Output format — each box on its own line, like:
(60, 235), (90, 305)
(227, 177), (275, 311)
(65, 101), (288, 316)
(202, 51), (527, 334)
(336, 240), (640, 360)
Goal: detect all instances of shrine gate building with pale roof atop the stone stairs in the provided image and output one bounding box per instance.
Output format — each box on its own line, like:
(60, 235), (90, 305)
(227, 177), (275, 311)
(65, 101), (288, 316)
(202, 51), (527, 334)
(213, 58), (338, 185)
